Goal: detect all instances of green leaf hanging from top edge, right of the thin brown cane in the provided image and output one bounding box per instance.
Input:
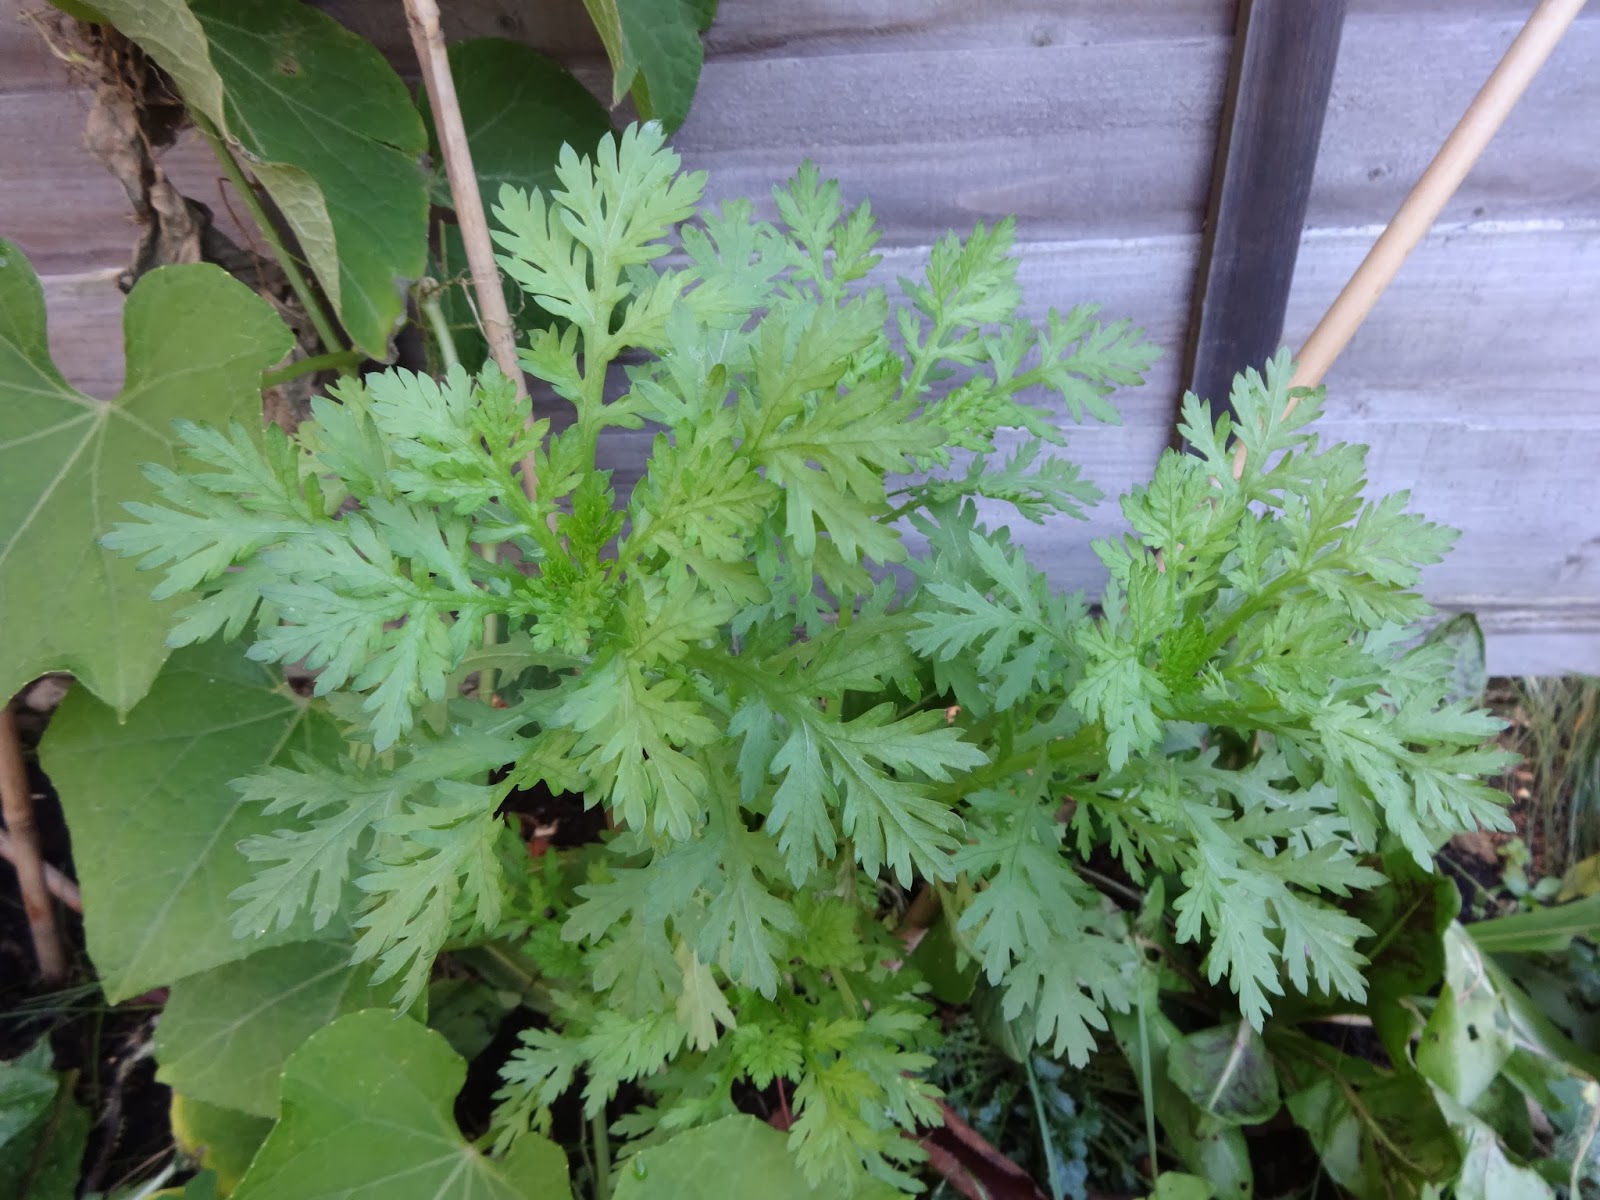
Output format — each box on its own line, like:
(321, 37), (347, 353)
(584, 0), (715, 133)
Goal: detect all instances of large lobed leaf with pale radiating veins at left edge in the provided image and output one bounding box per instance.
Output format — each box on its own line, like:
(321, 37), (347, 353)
(0, 240), (293, 714)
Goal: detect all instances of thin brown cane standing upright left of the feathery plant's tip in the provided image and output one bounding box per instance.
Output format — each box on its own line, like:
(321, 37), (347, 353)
(405, 0), (538, 498)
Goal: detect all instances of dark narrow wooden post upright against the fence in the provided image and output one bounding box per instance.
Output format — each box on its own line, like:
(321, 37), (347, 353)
(1184, 0), (1346, 432)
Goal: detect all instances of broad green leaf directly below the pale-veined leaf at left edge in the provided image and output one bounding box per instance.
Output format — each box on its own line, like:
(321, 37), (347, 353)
(40, 643), (342, 1003)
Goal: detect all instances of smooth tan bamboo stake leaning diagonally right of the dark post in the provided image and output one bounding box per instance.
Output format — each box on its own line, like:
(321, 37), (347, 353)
(1234, 0), (1586, 478)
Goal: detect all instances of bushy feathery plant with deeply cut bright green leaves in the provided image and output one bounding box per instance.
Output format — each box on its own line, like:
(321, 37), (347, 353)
(107, 126), (1506, 1195)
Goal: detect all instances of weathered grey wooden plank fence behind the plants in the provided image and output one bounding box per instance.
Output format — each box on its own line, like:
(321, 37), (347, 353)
(0, 0), (1600, 674)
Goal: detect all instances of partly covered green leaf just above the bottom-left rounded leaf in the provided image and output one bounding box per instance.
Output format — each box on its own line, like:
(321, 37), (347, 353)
(155, 942), (387, 1117)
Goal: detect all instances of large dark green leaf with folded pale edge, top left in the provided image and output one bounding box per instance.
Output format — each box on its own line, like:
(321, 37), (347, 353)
(98, 0), (427, 358)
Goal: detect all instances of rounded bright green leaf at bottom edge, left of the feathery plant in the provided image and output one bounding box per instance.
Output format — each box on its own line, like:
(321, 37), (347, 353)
(234, 1010), (571, 1200)
